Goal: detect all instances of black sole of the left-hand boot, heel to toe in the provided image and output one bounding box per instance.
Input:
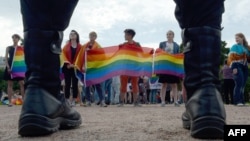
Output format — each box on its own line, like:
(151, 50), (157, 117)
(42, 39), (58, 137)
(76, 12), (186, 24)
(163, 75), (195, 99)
(18, 114), (82, 136)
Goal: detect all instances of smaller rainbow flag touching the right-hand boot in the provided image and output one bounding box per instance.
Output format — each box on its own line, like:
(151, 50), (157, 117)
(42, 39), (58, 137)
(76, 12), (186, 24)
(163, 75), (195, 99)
(154, 49), (184, 77)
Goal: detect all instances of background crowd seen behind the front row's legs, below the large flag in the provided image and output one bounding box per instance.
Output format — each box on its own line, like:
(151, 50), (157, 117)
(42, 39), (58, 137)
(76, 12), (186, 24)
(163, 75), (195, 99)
(74, 76), (184, 107)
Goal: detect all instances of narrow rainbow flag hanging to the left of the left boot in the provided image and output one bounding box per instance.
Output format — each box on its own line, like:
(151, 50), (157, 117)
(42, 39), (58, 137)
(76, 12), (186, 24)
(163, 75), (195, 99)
(11, 46), (27, 78)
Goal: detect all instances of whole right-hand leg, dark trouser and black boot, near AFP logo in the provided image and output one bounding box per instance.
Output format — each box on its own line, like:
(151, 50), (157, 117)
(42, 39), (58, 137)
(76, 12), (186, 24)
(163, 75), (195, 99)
(175, 0), (226, 138)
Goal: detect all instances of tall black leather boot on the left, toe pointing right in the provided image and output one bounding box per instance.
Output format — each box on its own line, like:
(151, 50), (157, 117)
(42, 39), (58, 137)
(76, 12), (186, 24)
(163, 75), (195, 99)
(18, 30), (82, 136)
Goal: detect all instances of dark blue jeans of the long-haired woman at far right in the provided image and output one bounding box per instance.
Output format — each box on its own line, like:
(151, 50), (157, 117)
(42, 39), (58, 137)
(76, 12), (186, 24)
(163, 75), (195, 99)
(233, 64), (248, 104)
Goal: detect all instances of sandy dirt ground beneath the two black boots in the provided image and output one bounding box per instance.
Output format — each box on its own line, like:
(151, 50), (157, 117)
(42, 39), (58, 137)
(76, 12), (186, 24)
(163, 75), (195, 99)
(0, 105), (250, 141)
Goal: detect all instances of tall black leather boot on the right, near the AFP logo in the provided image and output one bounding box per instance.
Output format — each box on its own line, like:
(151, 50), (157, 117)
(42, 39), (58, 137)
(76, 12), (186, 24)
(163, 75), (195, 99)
(182, 27), (226, 138)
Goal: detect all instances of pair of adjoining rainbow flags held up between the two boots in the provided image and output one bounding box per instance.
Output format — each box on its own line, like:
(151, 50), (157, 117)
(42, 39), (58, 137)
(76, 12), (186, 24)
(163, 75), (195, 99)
(73, 46), (184, 86)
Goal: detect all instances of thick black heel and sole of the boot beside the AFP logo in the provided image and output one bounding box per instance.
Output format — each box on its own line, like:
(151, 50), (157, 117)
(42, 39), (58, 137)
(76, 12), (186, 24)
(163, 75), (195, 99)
(189, 116), (225, 139)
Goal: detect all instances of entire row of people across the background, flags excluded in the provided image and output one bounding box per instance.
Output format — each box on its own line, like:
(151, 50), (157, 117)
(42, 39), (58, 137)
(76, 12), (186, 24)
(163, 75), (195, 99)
(4, 29), (249, 107)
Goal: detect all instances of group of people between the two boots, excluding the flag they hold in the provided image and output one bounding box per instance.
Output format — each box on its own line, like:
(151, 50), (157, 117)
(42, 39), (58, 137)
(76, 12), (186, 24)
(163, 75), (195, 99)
(58, 29), (186, 107)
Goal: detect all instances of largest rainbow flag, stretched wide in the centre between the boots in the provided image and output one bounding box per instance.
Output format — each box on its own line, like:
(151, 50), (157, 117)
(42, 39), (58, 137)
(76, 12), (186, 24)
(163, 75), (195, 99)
(85, 46), (153, 86)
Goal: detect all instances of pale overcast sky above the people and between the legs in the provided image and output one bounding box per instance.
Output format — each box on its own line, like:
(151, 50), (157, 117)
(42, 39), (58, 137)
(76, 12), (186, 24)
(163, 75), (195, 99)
(0, 0), (250, 56)
